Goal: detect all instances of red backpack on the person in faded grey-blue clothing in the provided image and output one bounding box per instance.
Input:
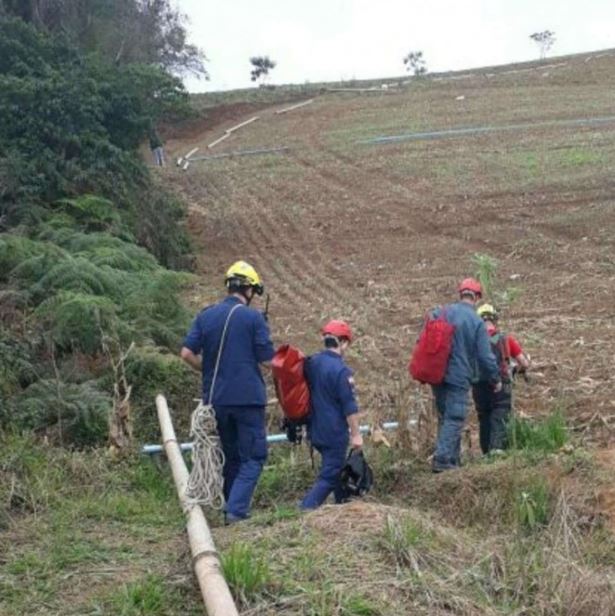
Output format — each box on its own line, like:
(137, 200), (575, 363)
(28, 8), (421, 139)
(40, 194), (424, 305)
(408, 309), (455, 385)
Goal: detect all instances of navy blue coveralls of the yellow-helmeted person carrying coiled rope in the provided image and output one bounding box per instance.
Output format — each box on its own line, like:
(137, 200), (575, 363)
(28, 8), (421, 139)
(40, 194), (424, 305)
(184, 296), (274, 520)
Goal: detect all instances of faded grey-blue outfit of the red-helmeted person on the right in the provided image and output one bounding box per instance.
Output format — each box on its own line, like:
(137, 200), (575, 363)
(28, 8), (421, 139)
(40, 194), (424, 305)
(433, 302), (500, 471)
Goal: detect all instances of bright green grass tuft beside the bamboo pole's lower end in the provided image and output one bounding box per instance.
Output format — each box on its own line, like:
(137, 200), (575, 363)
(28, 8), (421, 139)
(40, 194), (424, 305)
(222, 543), (270, 604)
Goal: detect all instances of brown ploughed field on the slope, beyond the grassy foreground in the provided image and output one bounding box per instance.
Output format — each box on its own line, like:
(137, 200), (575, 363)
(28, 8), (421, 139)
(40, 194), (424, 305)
(167, 54), (615, 436)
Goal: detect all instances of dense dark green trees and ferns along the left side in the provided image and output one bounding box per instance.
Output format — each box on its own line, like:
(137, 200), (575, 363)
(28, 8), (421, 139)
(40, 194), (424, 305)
(0, 0), (204, 446)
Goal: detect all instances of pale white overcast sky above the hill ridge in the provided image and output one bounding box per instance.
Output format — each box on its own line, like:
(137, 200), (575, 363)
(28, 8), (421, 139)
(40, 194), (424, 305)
(176, 0), (615, 91)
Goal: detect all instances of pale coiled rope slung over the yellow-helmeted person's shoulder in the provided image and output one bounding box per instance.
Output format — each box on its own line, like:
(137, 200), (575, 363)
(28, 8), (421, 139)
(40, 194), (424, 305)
(185, 304), (243, 509)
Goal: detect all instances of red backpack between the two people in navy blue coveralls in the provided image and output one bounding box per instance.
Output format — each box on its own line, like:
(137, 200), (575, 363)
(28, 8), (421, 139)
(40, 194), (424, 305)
(271, 344), (310, 422)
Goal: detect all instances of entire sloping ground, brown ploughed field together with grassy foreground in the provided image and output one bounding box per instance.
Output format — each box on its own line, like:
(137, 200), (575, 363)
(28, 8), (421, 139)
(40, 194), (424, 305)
(0, 54), (615, 616)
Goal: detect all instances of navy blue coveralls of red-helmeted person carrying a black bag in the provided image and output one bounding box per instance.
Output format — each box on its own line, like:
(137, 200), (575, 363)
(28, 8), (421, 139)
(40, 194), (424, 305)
(301, 350), (359, 509)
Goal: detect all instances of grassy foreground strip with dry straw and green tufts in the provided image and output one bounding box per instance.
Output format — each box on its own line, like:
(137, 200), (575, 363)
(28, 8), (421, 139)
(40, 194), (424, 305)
(0, 418), (615, 616)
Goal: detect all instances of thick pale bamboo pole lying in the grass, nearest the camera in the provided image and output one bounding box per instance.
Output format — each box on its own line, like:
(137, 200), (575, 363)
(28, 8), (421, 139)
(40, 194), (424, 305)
(156, 394), (239, 616)
